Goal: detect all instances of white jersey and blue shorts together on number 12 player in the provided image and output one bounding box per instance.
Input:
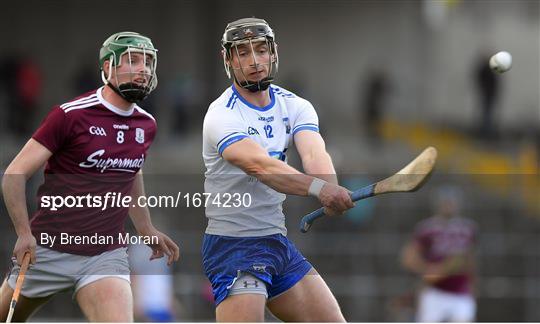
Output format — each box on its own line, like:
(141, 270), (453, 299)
(202, 86), (319, 305)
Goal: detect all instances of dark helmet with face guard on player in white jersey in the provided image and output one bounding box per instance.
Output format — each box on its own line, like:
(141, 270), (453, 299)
(221, 18), (279, 92)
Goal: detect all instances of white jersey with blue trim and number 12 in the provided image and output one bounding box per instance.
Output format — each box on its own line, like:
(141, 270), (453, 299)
(203, 85), (319, 237)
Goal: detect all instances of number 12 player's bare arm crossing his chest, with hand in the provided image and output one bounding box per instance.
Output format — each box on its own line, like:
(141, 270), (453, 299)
(223, 138), (354, 212)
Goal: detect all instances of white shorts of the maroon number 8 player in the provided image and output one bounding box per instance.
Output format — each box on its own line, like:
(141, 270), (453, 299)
(7, 245), (130, 298)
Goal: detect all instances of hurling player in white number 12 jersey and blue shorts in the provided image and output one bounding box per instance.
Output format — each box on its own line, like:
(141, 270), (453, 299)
(203, 18), (354, 322)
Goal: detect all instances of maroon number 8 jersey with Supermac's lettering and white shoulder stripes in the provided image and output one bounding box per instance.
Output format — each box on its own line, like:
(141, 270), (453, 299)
(31, 88), (156, 255)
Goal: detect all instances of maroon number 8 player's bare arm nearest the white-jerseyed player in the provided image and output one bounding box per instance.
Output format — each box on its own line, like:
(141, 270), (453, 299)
(129, 171), (180, 265)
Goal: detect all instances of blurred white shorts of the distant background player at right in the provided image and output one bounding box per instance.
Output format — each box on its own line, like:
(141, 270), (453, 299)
(416, 287), (476, 322)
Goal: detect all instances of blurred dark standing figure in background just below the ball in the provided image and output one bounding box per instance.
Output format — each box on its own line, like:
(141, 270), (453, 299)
(475, 54), (499, 138)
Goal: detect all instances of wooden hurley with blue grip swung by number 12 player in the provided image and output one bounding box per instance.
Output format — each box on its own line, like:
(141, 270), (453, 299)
(300, 146), (437, 233)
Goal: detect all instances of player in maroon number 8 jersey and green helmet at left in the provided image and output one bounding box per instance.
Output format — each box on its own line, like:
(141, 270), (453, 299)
(0, 32), (179, 322)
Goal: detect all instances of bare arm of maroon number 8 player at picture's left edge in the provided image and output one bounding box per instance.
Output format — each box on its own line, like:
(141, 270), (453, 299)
(2, 139), (52, 264)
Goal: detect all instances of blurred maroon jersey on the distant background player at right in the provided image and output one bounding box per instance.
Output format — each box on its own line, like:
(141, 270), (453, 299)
(415, 216), (476, 293)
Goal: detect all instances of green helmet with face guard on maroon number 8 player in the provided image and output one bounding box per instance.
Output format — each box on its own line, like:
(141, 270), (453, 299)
(99, 32), (157, 103)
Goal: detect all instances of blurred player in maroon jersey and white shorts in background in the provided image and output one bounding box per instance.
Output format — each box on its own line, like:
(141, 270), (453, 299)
(402, 187), (476, 322)
